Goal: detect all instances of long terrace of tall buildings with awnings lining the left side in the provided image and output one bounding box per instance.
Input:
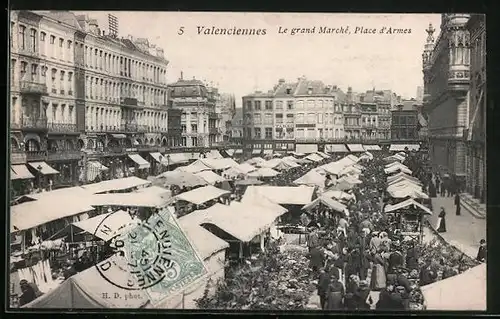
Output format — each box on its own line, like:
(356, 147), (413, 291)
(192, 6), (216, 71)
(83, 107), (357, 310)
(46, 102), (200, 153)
(11, 11), (168, 192)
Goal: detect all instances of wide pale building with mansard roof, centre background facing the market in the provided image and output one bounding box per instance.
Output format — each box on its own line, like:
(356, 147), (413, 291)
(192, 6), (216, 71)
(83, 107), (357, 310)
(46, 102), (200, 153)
(243, 77), (345, 153)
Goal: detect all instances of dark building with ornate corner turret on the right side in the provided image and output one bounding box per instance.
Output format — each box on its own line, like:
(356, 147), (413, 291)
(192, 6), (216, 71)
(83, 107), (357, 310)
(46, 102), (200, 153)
(422, 14), (470, 186)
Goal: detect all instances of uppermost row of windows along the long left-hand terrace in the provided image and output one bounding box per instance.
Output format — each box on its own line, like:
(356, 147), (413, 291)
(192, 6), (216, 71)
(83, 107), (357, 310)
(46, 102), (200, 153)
(10, 22), (167, 85)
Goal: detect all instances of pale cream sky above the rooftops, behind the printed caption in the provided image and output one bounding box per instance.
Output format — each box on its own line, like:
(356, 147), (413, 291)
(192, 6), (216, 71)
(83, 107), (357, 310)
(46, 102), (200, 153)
(75, 11), (441, 106)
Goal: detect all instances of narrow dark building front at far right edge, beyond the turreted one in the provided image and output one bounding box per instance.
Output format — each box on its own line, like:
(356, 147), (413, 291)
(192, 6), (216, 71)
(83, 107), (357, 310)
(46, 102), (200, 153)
(464, 14), (486, 203)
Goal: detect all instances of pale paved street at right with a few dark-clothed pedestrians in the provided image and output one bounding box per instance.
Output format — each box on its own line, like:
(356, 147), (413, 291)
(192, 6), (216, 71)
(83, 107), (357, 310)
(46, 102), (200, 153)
(428, 197), (486, 258)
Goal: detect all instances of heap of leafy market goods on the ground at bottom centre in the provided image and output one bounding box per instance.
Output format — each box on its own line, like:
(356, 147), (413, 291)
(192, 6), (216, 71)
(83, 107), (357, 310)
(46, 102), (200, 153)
(197, 247), (315, 310)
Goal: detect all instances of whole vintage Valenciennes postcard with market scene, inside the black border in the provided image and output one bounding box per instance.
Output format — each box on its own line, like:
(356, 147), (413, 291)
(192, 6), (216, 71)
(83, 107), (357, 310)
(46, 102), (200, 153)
(8, 10), (487, 312)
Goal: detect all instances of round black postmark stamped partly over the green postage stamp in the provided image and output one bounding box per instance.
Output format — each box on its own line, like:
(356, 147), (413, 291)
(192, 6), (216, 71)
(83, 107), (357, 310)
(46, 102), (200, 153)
(94, 211), (175, 290)
